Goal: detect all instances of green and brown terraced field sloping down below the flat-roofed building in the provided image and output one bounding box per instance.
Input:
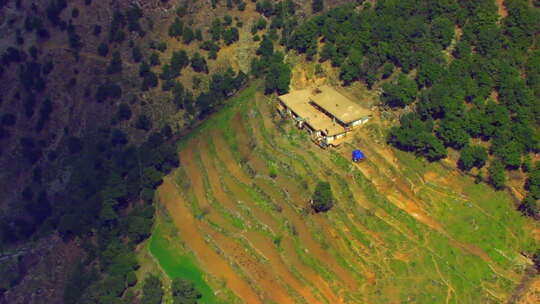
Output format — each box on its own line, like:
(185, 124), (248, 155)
(151, 83), (535, 304)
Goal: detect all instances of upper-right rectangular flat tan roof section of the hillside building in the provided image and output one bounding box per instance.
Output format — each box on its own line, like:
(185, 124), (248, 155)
(309, 85), (371, 124)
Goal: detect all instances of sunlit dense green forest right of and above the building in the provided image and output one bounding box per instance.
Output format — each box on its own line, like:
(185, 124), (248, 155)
(287, 0), (540, 215)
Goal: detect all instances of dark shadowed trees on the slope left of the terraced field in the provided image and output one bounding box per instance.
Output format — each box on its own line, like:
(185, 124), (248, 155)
(0, 0), (274, 303)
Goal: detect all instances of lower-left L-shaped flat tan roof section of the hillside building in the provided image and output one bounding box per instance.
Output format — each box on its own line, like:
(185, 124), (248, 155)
(279, 89), (345, 136)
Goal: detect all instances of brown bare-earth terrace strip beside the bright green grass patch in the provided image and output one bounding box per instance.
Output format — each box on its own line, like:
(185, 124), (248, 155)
(158, 177), (262, 303)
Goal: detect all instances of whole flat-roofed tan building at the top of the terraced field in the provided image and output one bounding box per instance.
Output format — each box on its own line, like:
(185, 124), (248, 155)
(277, 85), (371, 147)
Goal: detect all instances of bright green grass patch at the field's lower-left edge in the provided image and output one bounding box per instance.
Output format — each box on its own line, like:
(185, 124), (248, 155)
(148, 226), (218, 304)
